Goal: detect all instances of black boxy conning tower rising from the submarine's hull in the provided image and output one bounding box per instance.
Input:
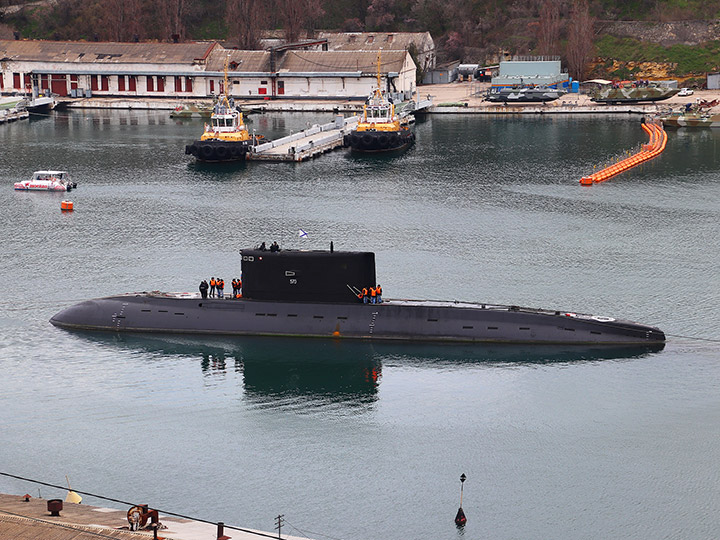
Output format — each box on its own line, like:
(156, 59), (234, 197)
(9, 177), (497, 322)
(240, 249), (376, 303)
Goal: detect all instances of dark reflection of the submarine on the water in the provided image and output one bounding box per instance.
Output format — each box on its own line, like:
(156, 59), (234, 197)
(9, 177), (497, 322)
(69, 332), (664, 403)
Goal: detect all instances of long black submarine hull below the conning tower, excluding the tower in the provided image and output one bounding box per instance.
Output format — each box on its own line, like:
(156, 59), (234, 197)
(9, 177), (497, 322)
(50, 293), (665, 344)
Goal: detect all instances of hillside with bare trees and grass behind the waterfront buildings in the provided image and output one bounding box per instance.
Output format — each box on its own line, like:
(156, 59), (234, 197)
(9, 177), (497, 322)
(0, 0), (720, 80)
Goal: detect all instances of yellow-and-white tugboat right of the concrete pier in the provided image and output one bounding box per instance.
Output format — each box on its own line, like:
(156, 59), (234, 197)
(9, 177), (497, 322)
(343, 51), (415, 152)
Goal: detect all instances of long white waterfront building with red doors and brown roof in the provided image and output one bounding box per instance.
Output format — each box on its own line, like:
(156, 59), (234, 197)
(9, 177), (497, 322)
(0, 40), (416, 99)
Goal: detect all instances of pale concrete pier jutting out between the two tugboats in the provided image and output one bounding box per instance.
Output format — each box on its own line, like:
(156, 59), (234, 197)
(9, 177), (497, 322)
(247, 116), (358, 161)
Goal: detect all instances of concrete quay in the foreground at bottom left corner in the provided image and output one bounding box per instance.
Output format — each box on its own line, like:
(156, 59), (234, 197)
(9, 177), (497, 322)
(0, 494), (308, 540)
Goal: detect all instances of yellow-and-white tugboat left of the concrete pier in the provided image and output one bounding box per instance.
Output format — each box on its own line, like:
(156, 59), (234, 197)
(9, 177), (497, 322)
(185, 60), (258, 162)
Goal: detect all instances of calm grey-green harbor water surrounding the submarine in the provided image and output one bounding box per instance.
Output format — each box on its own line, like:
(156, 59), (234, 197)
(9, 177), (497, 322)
(0, 107), (720, 540)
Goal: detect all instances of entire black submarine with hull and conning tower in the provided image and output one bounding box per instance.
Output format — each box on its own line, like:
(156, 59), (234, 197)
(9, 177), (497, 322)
(50, 244), (665, 345)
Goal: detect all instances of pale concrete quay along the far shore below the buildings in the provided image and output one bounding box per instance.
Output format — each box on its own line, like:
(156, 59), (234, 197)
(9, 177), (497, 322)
(63, 81), (720, 114)
